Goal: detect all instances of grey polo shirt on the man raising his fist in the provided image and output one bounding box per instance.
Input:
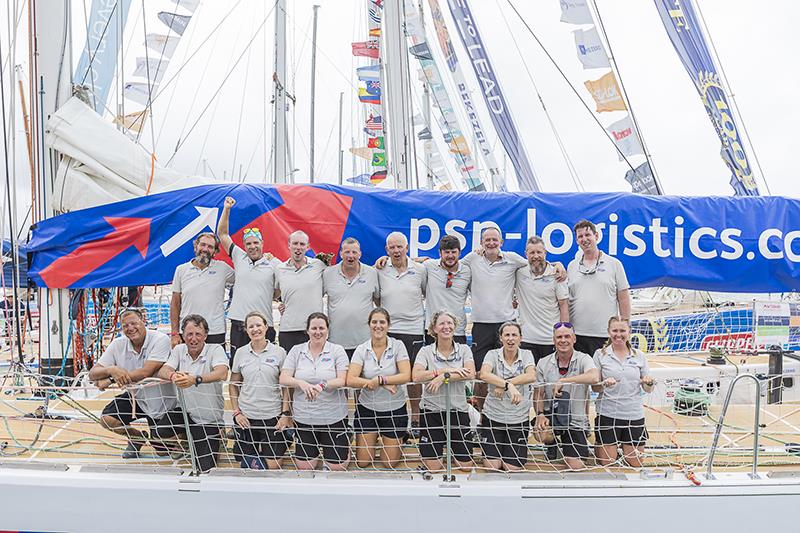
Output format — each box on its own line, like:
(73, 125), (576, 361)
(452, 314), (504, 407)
(228, 245), (275, 326)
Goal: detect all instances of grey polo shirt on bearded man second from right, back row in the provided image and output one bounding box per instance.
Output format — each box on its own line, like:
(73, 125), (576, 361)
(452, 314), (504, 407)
(516, 263), (569, 344)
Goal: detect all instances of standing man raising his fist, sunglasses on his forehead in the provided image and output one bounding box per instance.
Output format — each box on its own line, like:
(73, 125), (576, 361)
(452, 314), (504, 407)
(217, 196), (275, 362)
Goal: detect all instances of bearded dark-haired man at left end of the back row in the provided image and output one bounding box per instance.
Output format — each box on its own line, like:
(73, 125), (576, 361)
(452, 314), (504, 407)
(169, 232), (235, 348)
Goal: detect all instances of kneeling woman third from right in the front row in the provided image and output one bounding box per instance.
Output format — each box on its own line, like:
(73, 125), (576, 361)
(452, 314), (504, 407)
(479, 322), (536, 470)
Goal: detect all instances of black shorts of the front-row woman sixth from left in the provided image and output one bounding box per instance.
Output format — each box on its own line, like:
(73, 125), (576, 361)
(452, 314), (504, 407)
(419, 411), (472, 463)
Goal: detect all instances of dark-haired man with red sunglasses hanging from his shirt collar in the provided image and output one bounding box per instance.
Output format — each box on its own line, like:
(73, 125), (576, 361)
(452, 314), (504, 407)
(422, 235), (472, 344)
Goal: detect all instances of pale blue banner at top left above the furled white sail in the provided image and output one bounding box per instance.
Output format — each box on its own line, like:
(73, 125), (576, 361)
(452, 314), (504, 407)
(73, 0), (131, 115)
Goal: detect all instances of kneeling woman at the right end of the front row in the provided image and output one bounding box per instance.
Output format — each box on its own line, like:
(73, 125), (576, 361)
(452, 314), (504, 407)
(592, 316), (654, 468)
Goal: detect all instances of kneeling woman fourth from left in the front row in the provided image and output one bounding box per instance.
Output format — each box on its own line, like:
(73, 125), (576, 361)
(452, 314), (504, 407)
(280, 313), (350, 470)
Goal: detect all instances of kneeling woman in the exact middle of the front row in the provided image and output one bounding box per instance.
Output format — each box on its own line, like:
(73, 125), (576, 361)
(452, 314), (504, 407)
(347, 307), (411, 468)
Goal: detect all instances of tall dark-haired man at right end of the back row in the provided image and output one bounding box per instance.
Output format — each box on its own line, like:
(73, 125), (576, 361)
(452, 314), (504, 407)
(567, 220), (631, 355)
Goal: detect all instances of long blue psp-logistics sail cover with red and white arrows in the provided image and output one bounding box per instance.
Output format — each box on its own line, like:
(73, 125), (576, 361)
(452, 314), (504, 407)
(26, 184), (800, 292)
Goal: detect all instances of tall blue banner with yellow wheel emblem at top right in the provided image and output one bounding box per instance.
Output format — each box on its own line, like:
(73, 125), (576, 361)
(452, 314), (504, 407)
(655, 0), (759, 196)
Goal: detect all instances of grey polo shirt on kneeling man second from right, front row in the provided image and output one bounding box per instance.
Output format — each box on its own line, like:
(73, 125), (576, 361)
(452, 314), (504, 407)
(536, 351), (596, 429)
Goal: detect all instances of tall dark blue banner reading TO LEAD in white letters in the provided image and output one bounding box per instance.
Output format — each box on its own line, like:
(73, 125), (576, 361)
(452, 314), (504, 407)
(447, 0), (540, 191)
